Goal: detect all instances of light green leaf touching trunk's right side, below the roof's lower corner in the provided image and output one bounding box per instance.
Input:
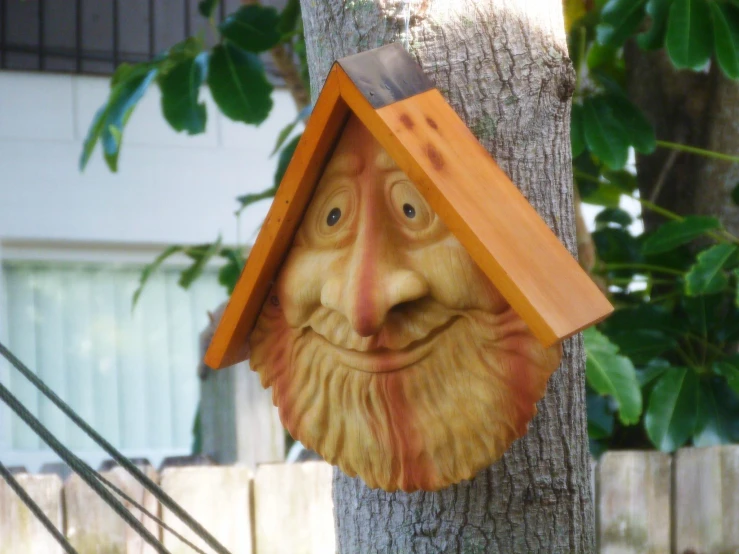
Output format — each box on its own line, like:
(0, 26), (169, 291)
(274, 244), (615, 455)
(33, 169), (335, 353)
(583, 327), (642, 425)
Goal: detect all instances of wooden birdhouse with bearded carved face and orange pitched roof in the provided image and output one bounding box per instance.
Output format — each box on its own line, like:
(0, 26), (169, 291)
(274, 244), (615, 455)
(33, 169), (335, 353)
(205, 44), (613, 490)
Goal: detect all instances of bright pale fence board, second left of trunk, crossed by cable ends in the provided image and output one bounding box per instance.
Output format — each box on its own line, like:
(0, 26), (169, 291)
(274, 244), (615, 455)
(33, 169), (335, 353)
(161, 466), (253, 554)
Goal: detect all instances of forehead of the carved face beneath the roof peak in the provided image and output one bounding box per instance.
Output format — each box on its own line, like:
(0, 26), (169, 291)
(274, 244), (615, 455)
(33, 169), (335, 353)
(323, 115), (399, 177)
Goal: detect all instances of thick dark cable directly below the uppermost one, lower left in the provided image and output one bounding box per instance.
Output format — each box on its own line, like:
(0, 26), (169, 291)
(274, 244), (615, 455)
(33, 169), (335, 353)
(0, 383), (172, 554)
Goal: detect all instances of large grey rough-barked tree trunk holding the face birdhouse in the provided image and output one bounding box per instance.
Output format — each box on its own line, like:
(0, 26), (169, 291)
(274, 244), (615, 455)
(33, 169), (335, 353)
(302, 0), (594, 554)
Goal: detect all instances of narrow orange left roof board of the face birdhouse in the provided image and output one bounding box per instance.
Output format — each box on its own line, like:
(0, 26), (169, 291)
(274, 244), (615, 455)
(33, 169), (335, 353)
(205, 66), (348, 369)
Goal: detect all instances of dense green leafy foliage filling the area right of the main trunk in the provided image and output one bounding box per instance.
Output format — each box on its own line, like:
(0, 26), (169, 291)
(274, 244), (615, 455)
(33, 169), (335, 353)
(566, 0), (739, 453)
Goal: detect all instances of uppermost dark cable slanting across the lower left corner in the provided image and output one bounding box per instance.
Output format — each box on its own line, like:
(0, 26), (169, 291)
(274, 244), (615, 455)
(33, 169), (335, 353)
(0, 343), (230, 554)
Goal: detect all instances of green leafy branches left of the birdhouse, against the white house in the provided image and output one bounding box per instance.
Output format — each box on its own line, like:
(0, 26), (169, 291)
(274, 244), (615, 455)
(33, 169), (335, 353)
(79, 0), (310, 300)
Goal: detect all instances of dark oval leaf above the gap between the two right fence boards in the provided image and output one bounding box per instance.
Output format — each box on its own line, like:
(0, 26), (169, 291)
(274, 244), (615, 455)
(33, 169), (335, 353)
(644, 367), (698, 452)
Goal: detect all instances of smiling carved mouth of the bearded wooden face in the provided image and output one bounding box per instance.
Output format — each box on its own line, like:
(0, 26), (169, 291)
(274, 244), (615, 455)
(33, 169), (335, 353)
(310, 317), (459, 373)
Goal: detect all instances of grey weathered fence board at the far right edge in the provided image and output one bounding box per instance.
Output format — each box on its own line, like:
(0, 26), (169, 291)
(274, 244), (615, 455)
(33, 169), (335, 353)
(675, 445), (739, 554)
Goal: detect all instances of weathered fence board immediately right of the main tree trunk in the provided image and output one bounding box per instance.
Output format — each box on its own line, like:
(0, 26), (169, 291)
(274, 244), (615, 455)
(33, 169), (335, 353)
(597, 451), (672, 554)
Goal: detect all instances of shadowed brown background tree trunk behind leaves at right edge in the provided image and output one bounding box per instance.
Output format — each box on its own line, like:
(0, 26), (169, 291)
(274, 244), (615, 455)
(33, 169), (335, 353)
(626, 41), (739, 233)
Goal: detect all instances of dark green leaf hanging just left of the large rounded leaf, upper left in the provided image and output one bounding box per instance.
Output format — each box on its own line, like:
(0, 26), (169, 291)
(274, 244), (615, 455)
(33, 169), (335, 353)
(159, 52), (208, 135)
